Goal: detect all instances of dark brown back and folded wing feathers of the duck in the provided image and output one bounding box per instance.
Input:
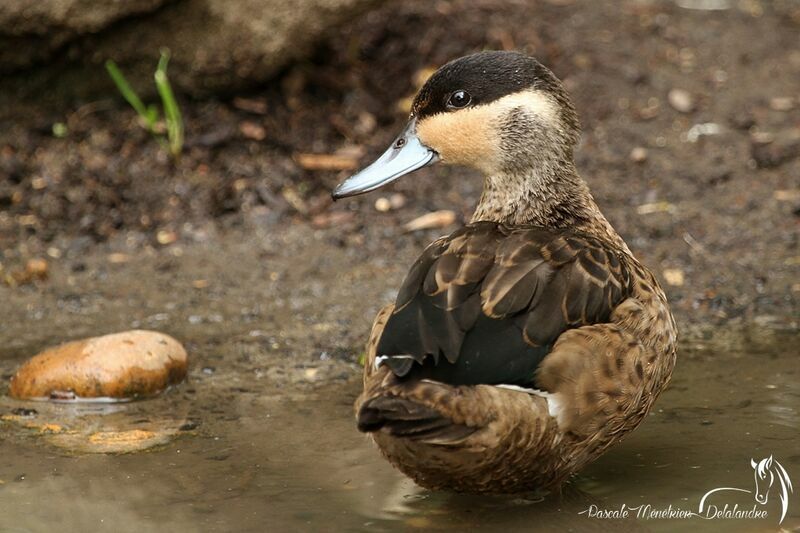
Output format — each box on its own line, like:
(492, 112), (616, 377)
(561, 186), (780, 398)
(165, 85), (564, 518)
(377, 222), (638, 386)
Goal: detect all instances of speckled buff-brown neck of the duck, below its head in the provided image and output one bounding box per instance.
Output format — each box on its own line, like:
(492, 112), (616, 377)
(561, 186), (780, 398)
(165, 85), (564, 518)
(472, 161), (629, 251)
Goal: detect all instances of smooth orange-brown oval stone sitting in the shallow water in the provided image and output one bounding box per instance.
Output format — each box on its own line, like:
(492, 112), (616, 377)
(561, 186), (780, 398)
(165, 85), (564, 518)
(9, 330), (187, 399)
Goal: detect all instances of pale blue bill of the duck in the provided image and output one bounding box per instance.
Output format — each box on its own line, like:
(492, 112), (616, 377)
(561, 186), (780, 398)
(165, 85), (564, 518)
(332, 119), (439, 200)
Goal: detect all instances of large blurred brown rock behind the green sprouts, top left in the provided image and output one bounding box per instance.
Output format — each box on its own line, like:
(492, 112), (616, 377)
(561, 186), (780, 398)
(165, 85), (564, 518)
(0, 0), (381, 104)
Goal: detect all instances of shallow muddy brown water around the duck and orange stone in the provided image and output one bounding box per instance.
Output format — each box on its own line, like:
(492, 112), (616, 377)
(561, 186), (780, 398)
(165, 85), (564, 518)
(0, 328), (800, 532)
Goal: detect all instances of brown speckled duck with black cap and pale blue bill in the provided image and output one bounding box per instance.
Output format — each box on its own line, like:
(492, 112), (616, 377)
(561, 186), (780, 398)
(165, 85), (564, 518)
(332, 51), (677, 493)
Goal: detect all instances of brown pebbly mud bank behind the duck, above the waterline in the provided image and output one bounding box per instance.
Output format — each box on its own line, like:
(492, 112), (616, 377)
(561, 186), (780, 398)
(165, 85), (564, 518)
(0, 0), (800, 358)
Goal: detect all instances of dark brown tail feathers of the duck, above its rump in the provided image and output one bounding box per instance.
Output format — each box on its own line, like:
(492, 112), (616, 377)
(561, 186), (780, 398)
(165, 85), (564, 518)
(356, 395), (477, 444)
